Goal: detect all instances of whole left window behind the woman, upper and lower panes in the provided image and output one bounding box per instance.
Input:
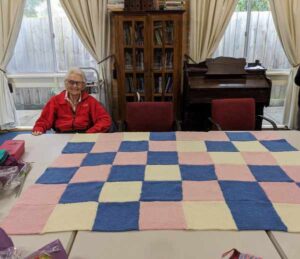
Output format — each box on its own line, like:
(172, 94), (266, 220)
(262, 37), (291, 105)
(7, 0), (97, 126)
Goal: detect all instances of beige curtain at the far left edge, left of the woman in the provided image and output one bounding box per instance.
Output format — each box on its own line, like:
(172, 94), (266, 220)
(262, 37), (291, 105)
(0, 0), (25, 130)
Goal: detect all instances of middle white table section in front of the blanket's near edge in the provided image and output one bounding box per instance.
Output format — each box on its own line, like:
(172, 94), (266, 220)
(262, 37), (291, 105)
(70, 231), (280, 259)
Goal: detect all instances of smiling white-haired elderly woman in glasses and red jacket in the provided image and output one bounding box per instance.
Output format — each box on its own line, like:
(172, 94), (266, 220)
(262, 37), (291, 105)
(32, 68), (111, 136)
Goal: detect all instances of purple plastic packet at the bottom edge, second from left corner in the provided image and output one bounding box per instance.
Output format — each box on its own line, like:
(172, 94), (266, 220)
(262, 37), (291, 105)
(25, 239), (68, 259)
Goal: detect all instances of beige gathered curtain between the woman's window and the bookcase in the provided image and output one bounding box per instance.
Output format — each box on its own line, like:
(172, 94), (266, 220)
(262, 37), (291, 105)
(60, 0), (110, 109)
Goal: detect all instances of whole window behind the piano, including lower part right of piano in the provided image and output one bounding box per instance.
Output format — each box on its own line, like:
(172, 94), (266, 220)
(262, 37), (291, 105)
(214, 0), (291, 126)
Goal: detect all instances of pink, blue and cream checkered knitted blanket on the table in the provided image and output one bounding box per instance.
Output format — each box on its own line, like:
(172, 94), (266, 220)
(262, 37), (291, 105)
(2, 132), (300, 234)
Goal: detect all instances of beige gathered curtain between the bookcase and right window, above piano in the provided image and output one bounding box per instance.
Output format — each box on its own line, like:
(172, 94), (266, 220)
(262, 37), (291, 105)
(189, 0), (238, 62)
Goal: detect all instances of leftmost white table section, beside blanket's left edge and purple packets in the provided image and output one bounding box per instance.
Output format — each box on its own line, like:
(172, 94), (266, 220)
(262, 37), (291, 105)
(0, 134), (76, 256)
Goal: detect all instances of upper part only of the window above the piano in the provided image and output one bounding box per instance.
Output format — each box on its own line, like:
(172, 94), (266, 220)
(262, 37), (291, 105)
(214, 0), (290, 69)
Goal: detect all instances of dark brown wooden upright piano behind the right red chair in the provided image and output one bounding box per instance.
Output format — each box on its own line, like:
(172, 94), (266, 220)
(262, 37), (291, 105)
(182, 57), (272, 131)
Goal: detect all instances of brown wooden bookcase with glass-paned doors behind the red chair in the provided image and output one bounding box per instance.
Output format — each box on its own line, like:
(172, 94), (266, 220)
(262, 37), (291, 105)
(112, 10), (184, 120)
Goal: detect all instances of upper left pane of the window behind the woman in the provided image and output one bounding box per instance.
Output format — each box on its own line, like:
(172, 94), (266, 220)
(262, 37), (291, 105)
(7, 0), (55, 74)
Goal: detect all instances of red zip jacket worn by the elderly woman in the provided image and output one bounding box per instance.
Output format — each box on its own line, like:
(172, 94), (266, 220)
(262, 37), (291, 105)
(33, 91), (111, 133)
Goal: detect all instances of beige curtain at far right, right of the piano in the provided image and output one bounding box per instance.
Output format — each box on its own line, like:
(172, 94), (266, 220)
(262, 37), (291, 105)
(269, 0), (300, 129)
